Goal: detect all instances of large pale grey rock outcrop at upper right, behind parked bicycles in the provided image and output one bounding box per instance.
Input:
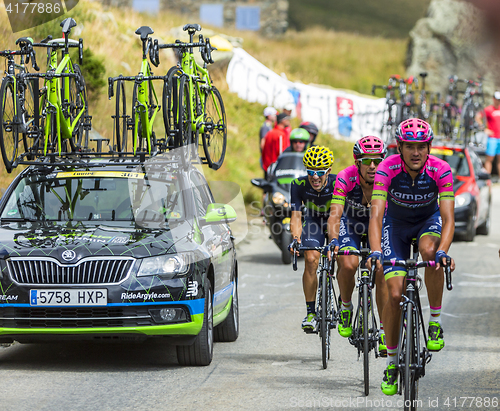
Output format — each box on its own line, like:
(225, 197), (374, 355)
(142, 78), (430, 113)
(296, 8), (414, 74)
(407, 0), (500, 94)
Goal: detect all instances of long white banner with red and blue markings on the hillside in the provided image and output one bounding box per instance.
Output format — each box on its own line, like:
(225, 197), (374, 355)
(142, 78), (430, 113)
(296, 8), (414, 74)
(226, 48), (385, 141)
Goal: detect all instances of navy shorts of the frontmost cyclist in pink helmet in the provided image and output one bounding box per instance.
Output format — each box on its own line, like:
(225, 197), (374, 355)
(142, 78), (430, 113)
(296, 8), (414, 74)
(382, 210), (442, 280)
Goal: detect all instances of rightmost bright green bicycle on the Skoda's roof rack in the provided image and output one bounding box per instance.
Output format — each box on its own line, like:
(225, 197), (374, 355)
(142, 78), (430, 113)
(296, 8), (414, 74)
(154, 24), (227, 170)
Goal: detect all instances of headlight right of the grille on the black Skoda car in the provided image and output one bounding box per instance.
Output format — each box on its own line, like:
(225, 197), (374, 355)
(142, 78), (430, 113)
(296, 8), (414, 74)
(137, 253), (193, 278)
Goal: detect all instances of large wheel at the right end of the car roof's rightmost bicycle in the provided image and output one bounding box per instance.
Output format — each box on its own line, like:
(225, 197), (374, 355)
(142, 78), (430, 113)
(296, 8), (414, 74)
(202, 87), (227, 170)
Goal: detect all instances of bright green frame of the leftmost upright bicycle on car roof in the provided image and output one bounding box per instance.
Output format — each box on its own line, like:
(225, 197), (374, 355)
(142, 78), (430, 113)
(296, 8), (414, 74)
(40, 46), (86, 155)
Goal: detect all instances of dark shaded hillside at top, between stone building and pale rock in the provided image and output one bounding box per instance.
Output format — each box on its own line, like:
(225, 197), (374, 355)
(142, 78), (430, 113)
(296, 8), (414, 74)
(288, 0), (430, 38)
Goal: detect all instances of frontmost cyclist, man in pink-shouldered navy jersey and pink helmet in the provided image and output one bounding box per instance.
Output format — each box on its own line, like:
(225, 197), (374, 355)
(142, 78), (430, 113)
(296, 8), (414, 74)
(368, 118), (455, 395)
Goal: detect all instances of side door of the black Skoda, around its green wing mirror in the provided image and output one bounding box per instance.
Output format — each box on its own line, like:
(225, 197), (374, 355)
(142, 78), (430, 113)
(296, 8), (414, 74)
(191, 171), (233, 315)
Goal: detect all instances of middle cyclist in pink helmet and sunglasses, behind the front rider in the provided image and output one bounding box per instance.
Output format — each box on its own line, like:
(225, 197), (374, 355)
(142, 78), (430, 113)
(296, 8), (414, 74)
(328, 136), (387, 357)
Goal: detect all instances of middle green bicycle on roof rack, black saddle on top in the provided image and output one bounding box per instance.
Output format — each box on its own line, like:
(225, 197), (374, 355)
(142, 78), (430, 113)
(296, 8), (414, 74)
(108, 26), (168, 155)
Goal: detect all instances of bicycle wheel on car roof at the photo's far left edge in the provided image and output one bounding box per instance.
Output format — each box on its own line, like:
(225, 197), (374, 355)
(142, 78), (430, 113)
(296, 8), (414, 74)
(0, 77), (18, 173)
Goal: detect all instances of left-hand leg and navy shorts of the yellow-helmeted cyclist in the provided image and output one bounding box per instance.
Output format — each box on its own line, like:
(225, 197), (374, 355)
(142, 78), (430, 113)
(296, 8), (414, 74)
(301, 216), (324, 332)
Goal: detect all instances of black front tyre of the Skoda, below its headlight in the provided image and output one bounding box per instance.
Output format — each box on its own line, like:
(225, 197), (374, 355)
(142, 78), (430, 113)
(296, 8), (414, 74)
(177, 278), (214, 366)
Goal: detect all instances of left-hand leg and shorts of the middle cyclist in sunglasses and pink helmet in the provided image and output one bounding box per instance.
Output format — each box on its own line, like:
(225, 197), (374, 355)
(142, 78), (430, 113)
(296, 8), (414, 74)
(337, 217), (361, 338)
